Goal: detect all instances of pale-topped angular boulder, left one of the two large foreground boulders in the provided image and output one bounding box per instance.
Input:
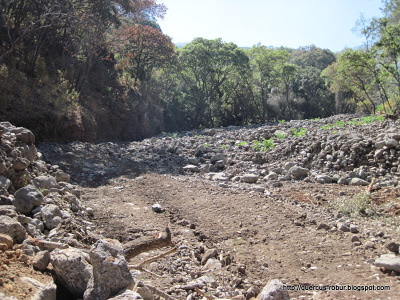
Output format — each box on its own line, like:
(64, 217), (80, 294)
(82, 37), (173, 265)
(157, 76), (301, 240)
(51, 248), (92, 298)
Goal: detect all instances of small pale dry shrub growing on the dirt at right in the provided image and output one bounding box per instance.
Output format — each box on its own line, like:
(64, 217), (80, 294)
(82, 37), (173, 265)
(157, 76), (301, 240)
(334, 192), (374, 217)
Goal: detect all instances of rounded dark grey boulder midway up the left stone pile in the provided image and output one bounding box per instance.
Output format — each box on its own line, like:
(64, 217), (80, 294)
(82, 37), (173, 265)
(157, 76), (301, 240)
(13, 184), (43, 214)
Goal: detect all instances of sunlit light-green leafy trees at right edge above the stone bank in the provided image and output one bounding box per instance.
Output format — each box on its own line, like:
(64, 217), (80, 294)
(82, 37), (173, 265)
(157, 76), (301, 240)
(324, 0), (400, 115)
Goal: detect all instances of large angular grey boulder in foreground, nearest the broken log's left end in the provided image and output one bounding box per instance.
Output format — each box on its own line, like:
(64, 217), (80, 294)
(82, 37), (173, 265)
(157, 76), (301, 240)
(84, 239), (134, 300)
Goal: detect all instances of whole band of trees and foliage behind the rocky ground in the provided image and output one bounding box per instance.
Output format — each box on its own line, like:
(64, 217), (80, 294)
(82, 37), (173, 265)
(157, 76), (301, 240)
(0, 0), (400, 140)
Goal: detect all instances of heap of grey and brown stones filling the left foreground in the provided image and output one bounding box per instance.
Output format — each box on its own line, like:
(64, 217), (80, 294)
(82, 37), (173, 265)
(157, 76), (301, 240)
(0, 122), (289, 300)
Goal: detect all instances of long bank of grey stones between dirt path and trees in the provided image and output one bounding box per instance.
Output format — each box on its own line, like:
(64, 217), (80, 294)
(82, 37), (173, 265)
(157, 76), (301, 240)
(40, 115), (400, 190)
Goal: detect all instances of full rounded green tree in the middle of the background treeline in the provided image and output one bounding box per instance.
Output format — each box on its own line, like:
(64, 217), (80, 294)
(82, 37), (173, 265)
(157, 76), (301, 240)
(179, 38), (249, 127)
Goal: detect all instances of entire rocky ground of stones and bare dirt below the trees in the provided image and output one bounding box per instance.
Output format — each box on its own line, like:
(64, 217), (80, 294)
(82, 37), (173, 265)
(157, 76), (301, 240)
(0, 115), (400, 299)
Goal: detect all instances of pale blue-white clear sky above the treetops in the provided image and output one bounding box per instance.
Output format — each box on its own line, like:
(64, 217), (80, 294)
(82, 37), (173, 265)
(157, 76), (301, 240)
(157, 0), (382, 52)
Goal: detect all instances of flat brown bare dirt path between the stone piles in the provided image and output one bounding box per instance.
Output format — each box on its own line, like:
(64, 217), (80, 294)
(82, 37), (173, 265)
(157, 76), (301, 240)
(83, 173), (400, 299)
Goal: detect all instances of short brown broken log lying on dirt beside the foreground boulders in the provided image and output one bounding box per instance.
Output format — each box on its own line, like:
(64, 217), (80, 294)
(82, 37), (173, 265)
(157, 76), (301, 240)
(123, 227), (174, 261)
